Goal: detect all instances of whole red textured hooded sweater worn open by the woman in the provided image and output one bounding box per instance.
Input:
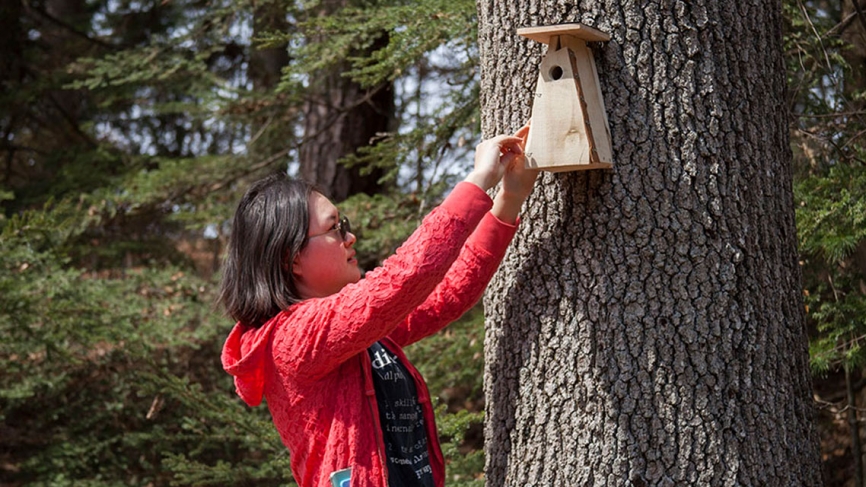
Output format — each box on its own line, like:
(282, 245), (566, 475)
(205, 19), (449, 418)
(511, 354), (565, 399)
(222, 183), (516, 487)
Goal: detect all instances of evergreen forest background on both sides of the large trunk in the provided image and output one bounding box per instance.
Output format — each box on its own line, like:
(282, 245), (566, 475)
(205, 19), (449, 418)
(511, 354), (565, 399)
(0, 0), (866, 486)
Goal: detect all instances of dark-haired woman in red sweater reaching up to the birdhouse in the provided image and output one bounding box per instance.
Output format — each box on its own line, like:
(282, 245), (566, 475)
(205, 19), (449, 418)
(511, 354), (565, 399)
(220, 127), (537, 487)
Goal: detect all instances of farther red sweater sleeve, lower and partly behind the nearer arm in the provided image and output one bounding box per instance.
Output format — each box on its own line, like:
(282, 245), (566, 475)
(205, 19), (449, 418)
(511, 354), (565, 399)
(389, 213), (519, 347)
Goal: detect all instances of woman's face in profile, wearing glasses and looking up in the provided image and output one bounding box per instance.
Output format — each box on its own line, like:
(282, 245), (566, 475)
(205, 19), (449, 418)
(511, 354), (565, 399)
(292, 192), (361, 299)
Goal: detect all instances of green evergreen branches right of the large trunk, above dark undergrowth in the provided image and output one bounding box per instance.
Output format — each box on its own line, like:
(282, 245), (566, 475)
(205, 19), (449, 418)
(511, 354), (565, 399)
(785, 1), (866, 373)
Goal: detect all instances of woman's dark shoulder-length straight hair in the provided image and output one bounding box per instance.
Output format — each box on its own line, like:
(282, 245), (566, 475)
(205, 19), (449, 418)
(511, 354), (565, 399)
(218, 173), (318, 327)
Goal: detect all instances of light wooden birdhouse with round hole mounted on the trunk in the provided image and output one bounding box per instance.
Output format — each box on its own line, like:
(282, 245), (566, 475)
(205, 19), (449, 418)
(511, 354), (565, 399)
(517, 24), (613, 172)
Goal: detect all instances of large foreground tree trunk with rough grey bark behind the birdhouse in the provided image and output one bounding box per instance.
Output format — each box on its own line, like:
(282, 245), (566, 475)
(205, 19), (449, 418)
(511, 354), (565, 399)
(478, 0), (822, 487)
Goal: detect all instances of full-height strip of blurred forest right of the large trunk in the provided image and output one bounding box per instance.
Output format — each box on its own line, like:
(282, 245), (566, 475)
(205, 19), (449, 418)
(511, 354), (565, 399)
(784, 0), (866, 486)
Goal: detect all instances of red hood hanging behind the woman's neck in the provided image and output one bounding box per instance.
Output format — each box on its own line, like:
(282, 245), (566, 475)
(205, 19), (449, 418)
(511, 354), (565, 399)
(221, 319), (276, 406)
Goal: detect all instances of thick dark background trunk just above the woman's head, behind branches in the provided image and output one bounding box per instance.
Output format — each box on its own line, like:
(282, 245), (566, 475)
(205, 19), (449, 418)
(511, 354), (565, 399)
(298, 0), (394, 201)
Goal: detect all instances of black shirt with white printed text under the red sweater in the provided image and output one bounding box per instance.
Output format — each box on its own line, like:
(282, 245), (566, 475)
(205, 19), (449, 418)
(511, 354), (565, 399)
(367, 342), (433, 487)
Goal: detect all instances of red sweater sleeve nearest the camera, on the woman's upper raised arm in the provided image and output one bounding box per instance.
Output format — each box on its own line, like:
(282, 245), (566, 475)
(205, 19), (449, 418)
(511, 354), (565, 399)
(272, 183), (492, 381)
